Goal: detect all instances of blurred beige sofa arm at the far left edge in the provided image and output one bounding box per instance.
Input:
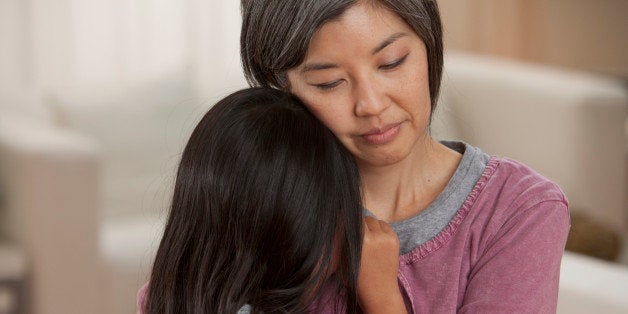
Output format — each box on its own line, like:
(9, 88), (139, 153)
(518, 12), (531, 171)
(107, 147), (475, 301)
(0, 91), (102, 313)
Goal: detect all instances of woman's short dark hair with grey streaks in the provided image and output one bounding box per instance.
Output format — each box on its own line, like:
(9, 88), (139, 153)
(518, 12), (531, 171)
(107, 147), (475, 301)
(240, 0), (443, 112)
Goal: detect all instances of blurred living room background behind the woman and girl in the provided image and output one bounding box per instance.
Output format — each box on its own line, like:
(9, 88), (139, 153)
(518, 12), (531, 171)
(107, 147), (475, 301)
(0, 0), (628, 314)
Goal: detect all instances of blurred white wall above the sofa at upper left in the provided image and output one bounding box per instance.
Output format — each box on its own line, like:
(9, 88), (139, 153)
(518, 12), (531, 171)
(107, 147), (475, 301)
(0, 0), (245, 100)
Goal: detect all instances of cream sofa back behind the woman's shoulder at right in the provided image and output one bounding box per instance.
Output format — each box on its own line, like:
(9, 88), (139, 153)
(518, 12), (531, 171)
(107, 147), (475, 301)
(434, 53), (628, 235)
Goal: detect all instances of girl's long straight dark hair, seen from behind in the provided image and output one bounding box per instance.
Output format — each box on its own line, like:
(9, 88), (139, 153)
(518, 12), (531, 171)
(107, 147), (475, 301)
(146, 88), (363, 313)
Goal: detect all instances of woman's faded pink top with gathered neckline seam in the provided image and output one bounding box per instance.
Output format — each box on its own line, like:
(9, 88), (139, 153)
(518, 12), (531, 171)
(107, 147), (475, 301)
(138, 157), (569, 313)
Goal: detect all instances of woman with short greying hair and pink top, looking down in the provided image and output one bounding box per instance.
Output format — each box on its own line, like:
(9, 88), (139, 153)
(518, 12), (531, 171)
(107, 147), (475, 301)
(241, 0), (569, 313)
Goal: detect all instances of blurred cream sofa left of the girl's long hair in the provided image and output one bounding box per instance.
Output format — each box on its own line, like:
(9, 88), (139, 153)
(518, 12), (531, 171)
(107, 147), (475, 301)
(0, 69), (245, 313)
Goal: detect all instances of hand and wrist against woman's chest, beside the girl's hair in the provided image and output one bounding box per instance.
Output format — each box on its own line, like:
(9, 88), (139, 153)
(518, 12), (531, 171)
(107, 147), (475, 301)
(358, 217), (406, 314)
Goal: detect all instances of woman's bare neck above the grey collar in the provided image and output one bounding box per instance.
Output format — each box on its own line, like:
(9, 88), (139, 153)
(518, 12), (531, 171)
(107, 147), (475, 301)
(360, 136), (462, 222)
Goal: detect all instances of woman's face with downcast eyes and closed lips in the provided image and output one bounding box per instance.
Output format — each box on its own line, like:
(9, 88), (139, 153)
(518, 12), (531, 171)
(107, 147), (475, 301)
(288, 3), (430, 166)
